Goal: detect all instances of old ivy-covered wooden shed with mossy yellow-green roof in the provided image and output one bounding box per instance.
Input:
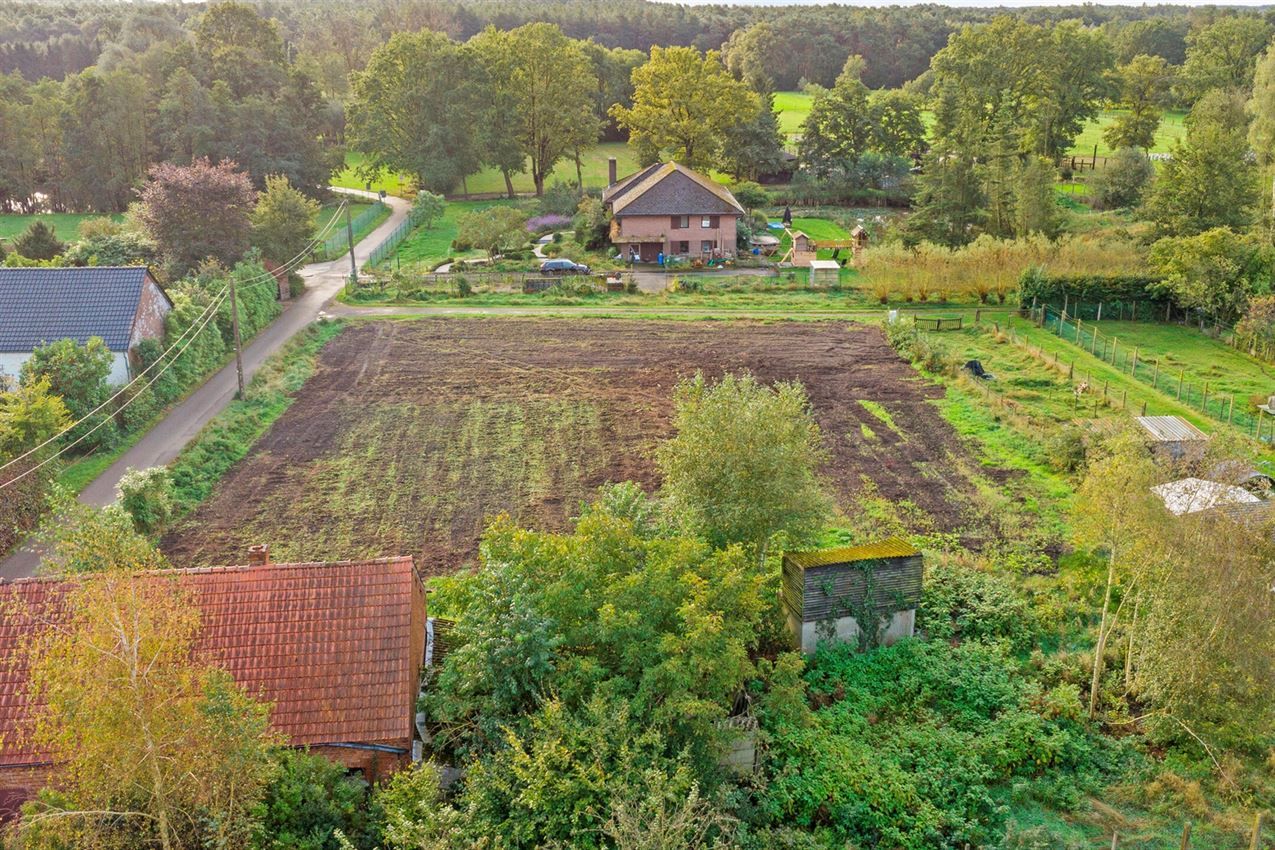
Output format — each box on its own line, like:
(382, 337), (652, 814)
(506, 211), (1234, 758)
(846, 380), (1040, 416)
(783, 538), (924, 652)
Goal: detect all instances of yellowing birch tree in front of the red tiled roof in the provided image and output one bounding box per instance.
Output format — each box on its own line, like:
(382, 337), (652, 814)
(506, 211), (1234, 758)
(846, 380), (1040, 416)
(18, 571), (274, 850)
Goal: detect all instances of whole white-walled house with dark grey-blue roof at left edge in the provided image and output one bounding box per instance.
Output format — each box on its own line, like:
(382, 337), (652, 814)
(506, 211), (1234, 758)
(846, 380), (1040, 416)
(0, 266), (172, 384)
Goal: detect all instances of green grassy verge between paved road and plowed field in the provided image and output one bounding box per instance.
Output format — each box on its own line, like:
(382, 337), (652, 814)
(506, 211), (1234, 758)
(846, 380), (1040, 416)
(171, 321), (344, 516)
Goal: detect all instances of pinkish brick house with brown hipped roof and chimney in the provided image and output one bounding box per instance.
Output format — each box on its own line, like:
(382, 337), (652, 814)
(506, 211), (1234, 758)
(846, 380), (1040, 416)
(602, 159), (745, 263)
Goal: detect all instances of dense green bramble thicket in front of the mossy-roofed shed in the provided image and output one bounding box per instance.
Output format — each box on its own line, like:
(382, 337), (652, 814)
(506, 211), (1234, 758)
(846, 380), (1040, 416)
(759, 640), (1108, 850)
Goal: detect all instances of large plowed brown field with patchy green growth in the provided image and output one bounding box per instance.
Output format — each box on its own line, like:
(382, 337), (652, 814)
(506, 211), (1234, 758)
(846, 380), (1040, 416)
(163, 319), (995, 573)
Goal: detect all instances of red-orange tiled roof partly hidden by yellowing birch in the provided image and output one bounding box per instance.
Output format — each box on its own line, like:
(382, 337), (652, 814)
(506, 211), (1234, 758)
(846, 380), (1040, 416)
(0, 557), (425, 766)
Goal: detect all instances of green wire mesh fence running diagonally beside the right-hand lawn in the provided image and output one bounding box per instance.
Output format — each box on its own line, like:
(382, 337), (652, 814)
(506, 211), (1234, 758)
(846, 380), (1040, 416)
(1033, 307), (1275, 441)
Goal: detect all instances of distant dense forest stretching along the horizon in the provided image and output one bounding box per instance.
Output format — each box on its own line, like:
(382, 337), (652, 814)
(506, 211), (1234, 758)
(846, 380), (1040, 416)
(0, 0), (1234, 90)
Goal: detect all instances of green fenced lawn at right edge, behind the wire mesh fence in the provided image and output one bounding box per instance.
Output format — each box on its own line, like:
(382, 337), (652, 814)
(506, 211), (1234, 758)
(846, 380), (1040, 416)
(1084, 321), (1275, 412)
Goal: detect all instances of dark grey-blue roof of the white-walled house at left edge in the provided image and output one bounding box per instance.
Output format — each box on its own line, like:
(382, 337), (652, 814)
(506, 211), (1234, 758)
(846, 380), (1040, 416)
(0, 266), (157, 352)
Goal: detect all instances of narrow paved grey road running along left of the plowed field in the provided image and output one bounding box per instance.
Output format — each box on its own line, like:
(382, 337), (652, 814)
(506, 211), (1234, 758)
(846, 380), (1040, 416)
(0, 189), (412, 579)
